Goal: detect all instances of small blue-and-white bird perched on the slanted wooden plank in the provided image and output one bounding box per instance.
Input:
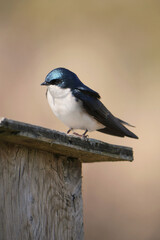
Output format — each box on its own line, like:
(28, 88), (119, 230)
(41, 67), (138, 139)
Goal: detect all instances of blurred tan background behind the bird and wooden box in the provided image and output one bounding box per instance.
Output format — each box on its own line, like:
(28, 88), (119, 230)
(0, 0), (160, 240)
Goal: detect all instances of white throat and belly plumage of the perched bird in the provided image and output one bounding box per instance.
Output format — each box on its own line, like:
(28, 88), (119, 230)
(47, 86), (104, 131)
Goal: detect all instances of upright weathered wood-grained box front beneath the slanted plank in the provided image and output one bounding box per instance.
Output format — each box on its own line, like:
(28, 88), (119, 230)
(0, 142), (83, 240)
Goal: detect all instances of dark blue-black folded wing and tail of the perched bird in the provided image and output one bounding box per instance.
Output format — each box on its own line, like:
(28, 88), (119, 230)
(72, 85), (138, 138)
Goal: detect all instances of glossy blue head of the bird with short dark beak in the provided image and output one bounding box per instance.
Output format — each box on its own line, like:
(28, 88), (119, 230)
(41, 68), (80, 89)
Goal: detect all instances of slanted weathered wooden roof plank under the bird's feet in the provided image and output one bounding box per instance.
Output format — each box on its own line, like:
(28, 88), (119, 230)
(0, 118), (133, 163)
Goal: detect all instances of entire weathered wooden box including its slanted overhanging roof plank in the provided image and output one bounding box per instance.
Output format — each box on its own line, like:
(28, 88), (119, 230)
(0, 118), (133, 240)
